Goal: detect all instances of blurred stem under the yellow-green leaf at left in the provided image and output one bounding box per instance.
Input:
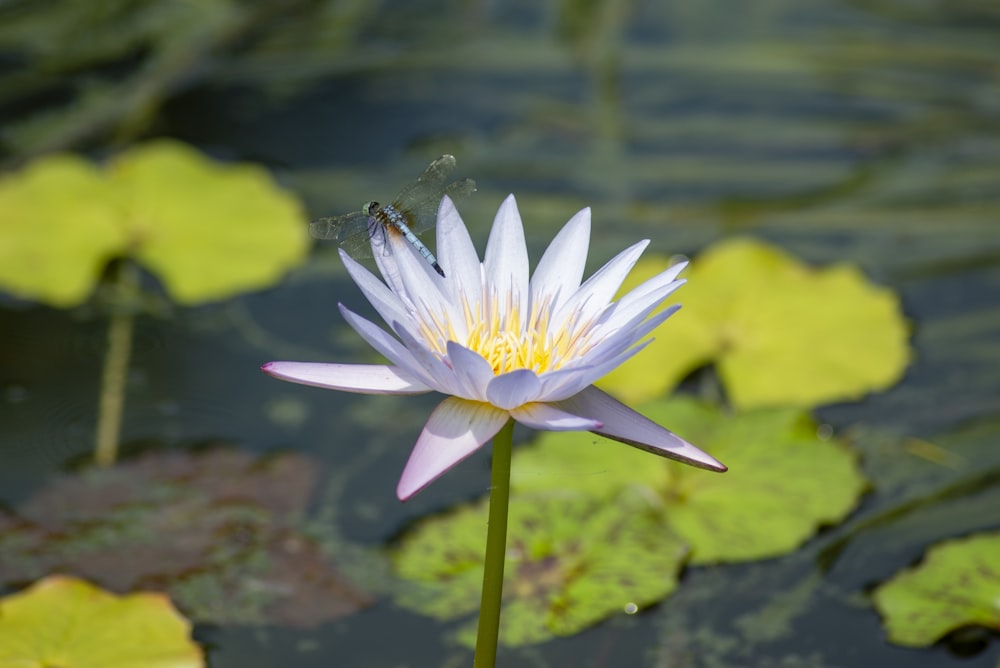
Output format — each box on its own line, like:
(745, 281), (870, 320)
(94, 260), (138, 466)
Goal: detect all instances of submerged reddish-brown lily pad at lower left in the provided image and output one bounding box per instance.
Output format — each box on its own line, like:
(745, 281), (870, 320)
(0, 448), (371, 627)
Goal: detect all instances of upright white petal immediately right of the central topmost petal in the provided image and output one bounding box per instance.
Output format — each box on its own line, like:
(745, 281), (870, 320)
(531, 207), (590, 306)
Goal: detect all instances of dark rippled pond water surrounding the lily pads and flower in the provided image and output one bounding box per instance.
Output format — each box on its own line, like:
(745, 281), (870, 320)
(0, 0), (1000, 668)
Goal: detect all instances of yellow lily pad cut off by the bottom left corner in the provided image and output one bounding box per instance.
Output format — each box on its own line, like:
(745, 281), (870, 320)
(0, 575), (205, 668)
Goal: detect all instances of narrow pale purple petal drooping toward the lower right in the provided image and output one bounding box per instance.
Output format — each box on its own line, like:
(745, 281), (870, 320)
(556, 387), (726, 471)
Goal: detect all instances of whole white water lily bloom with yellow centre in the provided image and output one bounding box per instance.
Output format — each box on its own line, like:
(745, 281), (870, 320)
(262, 195), (726, 501)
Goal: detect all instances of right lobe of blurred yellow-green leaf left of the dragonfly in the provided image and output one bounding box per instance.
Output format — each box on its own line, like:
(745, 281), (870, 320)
(111, 141), (308, 304)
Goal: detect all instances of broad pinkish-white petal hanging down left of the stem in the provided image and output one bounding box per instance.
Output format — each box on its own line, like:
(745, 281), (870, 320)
(396, 397), (510, 501)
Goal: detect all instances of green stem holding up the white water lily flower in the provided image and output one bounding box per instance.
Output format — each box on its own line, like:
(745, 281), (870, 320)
(472, 420), (514, 668)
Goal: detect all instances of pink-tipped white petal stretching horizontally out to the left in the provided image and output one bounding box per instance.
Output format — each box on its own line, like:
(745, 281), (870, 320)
(260, 362), (431, 394)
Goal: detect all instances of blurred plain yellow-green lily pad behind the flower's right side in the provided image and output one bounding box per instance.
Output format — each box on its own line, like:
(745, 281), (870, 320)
(600, 239), (910, 409)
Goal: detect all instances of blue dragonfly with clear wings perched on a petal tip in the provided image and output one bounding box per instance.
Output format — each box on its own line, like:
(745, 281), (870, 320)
(309, 155), (476, 276)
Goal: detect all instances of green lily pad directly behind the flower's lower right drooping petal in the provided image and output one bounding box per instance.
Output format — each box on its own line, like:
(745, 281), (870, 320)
(511, 397), (866, 564)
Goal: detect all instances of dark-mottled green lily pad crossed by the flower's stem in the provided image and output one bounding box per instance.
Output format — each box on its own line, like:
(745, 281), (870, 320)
(394, 493), (686, 647)
